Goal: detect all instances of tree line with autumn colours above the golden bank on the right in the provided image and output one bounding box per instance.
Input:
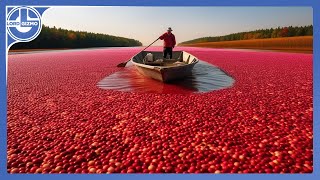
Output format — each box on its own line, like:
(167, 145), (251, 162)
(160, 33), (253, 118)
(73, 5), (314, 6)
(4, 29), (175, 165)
(181, 25), (313, 44)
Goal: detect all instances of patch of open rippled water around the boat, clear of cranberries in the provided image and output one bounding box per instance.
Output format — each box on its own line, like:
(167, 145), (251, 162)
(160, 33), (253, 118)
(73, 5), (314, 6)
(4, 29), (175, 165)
(98, 61), (234, 93)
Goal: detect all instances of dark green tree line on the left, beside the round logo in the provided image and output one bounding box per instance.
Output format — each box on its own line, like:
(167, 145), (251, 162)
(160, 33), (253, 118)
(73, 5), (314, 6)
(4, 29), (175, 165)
(11, 25), (142, 49)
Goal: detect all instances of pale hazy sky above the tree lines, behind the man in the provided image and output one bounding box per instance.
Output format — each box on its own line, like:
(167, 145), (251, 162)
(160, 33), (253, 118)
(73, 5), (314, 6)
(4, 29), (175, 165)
(42, 6), (313, 45)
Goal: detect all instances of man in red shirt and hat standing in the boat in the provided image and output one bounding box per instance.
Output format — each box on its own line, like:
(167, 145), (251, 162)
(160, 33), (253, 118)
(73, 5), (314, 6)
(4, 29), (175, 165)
(159, 27), (176, 59)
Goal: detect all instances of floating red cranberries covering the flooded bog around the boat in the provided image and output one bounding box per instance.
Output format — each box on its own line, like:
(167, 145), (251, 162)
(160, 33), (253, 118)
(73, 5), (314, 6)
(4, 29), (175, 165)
(7, 47), (313, 173)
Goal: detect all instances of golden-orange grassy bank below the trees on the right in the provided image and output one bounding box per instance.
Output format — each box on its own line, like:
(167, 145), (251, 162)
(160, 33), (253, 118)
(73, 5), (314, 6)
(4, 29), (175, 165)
(180, 36), (313, 53)
